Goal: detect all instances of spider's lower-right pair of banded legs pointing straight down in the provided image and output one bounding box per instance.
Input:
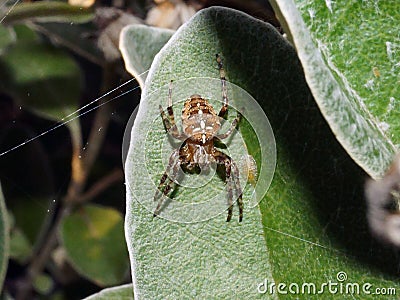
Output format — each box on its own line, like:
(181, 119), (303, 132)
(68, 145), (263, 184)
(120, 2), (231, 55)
(214, 151), (243, 222)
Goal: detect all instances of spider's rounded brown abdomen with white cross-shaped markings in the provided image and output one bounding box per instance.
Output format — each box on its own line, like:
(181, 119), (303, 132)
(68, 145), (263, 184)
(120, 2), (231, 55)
(182, 94), (221, 144)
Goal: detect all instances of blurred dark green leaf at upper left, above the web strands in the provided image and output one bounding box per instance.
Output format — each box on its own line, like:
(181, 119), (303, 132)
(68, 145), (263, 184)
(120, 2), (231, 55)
(0, 40), (82, 121)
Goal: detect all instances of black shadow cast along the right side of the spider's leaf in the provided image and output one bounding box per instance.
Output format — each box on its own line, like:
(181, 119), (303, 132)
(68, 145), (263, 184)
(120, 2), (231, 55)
(213, 8), (399, 278)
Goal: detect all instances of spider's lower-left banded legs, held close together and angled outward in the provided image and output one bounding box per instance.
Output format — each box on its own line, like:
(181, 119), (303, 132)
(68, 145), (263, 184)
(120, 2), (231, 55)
(153, 149), (180, 217)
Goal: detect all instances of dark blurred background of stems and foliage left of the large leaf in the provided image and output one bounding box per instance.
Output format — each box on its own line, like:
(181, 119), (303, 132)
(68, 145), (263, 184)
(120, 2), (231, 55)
(0, 0), (281, 299)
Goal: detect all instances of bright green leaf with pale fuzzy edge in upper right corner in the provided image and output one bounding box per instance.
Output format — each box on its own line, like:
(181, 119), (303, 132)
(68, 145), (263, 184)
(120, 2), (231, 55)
(271, 0), (400, 178)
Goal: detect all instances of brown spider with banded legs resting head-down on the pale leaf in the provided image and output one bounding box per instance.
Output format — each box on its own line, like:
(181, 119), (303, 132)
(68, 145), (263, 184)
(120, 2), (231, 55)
(153, 54), (243, 222)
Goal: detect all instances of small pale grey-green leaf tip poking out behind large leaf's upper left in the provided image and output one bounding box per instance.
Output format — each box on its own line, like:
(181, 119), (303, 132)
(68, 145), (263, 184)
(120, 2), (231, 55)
(119, 25), (174, 89)
